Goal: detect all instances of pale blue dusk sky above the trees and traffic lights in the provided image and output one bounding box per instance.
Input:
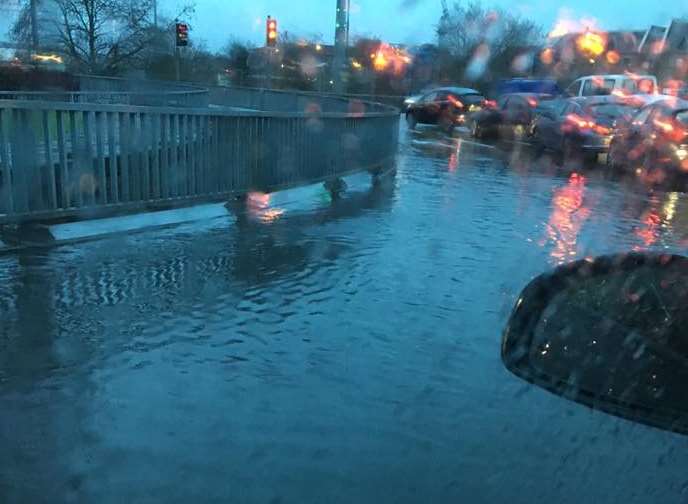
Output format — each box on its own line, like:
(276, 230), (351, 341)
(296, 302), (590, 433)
(159, 0), (676, 48)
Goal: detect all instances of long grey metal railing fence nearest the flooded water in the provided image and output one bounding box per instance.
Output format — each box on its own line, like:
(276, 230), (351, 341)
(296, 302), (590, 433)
(0, 98), (399, 223)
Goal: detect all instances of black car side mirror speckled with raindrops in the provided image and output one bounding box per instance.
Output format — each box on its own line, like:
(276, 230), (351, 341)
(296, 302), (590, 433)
(502, 253), (688, 434)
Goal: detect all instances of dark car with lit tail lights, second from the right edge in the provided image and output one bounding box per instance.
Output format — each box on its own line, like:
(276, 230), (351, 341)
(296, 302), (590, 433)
(531, 96), (638, 161)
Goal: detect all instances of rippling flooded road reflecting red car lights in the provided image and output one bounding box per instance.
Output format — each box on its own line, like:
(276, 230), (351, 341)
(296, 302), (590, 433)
(0, 123), (688, 504)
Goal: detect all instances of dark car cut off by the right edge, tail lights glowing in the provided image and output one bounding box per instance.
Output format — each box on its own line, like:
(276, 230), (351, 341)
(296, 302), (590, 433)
(607, 98), (688, 177)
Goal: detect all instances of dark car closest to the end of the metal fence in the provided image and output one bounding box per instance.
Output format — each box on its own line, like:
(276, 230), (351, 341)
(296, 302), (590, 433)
(406, 87), (485, 130)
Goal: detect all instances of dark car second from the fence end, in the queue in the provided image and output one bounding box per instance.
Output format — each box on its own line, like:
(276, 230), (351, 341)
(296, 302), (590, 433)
(468, 93), (552, 139)
